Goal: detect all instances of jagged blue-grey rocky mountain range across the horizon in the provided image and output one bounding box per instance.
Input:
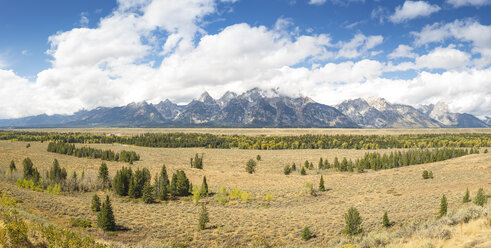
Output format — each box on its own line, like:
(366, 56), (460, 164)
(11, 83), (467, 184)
(0, 88), (491, 128)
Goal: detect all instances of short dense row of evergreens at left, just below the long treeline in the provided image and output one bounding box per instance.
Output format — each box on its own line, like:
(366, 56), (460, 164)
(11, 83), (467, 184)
(48, 142), (140, 163)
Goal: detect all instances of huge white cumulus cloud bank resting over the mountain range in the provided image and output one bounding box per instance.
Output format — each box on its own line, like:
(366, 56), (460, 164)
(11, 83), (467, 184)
(0, 0), (491, 118)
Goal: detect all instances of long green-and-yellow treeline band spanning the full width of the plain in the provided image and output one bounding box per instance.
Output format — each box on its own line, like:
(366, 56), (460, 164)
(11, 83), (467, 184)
(0, 131), (491, 150)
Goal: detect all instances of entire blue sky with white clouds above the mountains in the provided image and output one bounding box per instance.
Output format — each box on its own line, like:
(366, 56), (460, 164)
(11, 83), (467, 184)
(0, 0), (491, 118)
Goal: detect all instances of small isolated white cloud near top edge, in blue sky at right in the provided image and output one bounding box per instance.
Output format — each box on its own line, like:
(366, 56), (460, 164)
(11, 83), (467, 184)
(389, 1), (441, 23)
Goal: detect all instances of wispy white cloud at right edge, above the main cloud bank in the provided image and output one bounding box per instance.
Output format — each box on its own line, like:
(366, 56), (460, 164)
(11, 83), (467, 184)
(412, 20), (491, 67)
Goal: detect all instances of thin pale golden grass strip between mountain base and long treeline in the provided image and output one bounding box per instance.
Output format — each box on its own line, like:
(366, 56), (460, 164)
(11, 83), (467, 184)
(5, 128), (491, 136)
